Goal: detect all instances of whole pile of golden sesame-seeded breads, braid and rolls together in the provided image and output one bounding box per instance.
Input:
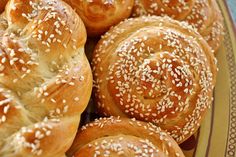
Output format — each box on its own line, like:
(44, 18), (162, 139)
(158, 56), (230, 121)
(0, 0), (224, 157)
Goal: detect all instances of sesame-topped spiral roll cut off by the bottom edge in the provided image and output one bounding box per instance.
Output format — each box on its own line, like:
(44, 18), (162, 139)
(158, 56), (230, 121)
(68, 117), (184, 157)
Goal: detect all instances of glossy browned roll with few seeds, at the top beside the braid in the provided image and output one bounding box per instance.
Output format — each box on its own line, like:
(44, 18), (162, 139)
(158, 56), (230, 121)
(64, 0), (134, 36)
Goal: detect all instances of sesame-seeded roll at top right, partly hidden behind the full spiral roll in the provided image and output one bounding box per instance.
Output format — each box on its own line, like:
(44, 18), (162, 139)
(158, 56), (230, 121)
(133, 0), (224, 52)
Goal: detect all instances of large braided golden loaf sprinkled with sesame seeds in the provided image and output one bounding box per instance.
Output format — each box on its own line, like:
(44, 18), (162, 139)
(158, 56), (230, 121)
(0, 0), (92, 157)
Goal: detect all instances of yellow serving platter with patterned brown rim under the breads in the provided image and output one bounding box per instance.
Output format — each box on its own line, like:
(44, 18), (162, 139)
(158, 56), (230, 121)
(81, 0), (236, 157)
